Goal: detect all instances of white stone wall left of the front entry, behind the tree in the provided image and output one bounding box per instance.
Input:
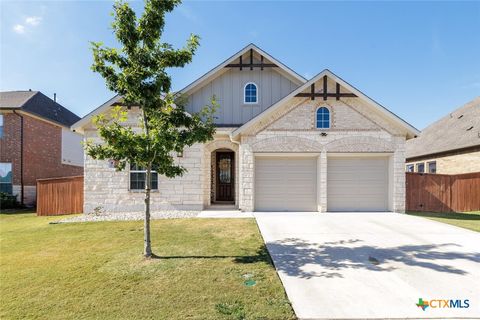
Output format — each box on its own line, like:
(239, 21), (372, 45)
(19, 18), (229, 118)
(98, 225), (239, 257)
(84, 131), (204, 213)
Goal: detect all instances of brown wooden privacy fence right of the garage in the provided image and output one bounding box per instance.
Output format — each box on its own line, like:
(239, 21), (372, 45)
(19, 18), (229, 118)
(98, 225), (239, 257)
(406, 172), (480, 212)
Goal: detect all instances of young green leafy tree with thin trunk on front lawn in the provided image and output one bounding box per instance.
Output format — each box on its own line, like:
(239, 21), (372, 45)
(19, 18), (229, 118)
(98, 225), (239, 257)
(85, 0), (215, 258)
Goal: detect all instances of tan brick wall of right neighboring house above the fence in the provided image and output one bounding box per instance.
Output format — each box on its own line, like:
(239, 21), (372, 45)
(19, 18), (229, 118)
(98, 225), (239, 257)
(406, 151), (480, 174)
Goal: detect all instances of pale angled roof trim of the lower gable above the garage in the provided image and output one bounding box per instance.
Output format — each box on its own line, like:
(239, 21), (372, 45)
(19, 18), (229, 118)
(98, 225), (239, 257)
(232, 69), (420, 138)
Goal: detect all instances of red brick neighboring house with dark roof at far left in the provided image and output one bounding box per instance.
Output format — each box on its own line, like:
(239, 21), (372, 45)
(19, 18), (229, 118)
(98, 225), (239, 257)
(0, 91), (83, 205)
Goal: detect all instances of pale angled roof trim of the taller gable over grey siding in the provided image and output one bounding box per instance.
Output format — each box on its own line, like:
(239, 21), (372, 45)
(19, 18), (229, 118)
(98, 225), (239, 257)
(179, 43), (307, 94)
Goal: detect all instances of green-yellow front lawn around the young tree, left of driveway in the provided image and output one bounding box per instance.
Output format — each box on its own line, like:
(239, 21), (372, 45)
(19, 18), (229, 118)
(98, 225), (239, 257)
(0, 214), (295, 319)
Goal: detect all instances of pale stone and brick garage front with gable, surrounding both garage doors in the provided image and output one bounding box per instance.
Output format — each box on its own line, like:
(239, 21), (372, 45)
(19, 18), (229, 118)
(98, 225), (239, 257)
(239, 98), (405, 212)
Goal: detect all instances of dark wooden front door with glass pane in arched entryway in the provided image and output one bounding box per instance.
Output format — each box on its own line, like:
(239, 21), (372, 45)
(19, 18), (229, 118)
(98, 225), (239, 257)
(216, 152), (235, 201)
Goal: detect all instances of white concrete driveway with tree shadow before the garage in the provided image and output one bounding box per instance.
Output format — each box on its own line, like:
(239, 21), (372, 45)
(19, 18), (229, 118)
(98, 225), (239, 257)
(254, 213), (480, 319)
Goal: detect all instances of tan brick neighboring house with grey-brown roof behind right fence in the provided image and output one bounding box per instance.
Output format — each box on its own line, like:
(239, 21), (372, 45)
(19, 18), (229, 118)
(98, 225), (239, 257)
(405, 97), (480, 174)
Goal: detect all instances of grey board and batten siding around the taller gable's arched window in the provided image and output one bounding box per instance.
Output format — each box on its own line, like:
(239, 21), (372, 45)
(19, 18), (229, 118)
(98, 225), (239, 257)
(186, 68), (298, 125)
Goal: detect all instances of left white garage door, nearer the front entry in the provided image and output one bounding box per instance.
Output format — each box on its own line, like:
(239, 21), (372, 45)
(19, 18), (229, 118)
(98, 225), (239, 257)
(255, 157), (317, 211)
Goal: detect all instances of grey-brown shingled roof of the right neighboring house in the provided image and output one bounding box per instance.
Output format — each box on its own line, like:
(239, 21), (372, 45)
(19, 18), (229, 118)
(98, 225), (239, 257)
(406, 97), (480, 159)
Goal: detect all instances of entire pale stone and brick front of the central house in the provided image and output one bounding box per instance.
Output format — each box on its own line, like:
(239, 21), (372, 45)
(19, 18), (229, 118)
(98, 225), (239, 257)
(84, 92), (406, 213)
